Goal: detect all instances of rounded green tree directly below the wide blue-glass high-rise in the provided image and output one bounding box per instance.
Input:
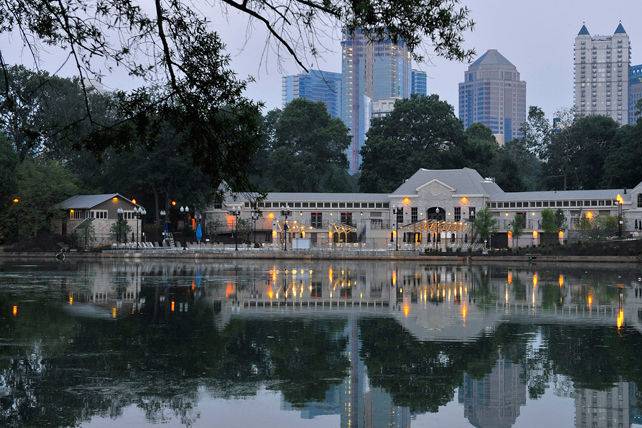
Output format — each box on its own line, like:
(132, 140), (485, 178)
(254, 98), (352, 192)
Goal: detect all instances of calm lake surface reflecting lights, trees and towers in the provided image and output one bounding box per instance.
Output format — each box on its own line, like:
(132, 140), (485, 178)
(0, 262), (642, 428)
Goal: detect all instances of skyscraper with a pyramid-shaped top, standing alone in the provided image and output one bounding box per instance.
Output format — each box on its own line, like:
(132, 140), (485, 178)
(459, 49), (526, 144)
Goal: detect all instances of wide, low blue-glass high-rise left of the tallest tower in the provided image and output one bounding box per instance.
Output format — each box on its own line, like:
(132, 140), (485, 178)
(281, 70), (341, 117)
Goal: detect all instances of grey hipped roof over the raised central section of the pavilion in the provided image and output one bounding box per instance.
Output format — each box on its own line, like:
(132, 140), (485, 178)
(392, 168), (504, 196)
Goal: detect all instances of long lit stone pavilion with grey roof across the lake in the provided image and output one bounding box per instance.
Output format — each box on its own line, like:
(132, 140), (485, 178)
(206, 168), (642, 251)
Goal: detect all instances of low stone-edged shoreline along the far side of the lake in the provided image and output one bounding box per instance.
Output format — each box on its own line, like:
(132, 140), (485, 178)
(0, 249), (642, 265)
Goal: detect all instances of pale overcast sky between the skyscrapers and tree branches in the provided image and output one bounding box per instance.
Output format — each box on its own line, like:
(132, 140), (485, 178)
(0, 0), (642, 116)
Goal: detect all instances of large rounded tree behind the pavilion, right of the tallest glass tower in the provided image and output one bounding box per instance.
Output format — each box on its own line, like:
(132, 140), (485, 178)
(359, 95), (466, 193)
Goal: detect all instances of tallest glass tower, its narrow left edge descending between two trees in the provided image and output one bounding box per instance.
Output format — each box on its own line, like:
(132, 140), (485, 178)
(341, 30), (411, 173)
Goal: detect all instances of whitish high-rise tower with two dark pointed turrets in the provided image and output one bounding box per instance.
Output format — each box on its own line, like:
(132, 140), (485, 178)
(575, 23), (631, 125)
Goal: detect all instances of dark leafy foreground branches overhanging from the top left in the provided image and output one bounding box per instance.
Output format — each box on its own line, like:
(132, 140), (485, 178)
(0, 0), (474, 190)
